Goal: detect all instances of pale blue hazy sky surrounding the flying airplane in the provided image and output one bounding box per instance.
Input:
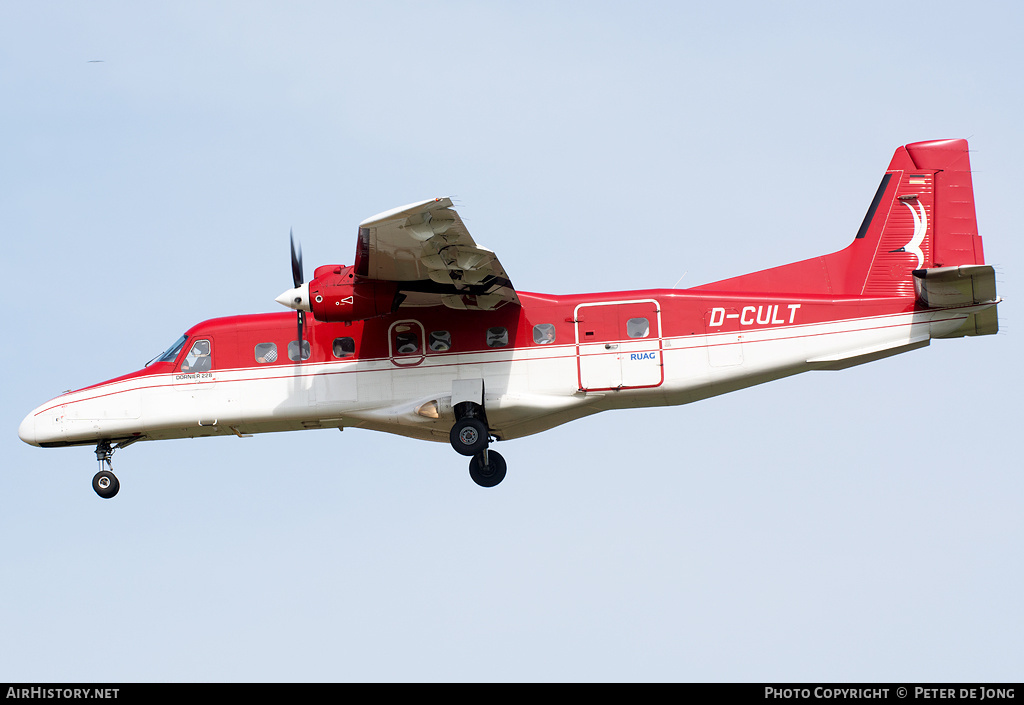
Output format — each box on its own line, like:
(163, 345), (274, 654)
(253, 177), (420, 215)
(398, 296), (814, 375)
(0, 0), (1024, 681)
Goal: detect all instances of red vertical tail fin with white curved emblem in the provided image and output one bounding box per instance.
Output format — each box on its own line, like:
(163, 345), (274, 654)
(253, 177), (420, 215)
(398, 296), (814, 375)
(696, 139), (984, 297)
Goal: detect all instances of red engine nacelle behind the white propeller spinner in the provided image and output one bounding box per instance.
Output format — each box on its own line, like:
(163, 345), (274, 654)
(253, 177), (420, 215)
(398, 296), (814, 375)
(309, 265), (401, 322)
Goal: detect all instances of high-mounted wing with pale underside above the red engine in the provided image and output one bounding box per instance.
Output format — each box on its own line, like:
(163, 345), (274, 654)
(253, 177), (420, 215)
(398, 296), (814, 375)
(354, 198), (519, 310)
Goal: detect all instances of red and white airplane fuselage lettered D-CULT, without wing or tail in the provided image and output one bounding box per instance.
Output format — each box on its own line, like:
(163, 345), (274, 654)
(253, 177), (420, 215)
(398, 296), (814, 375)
(18, 290), (991, 447)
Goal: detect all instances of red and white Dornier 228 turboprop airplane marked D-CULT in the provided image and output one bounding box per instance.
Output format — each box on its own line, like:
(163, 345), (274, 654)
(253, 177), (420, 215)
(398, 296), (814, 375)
(18, 139), (998, 498)
